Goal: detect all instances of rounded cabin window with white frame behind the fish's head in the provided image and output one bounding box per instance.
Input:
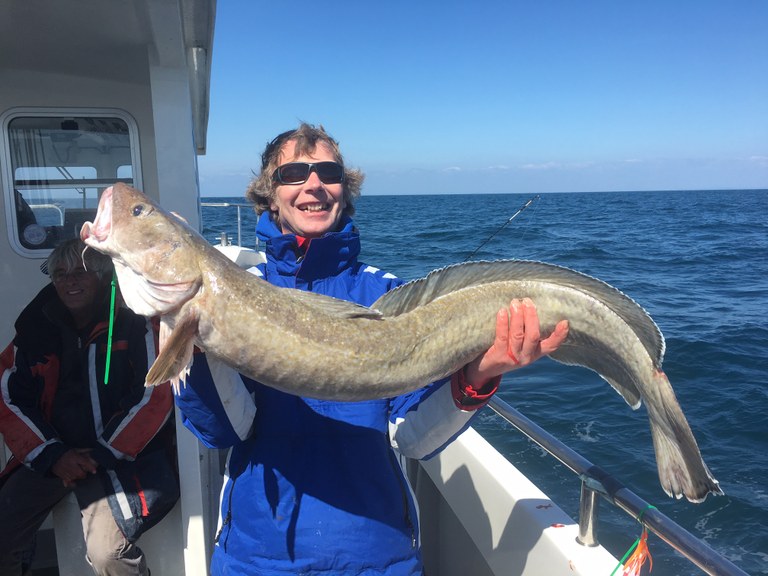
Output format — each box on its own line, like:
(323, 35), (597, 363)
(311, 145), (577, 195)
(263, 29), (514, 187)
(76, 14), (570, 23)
(2, 111), (141, 256)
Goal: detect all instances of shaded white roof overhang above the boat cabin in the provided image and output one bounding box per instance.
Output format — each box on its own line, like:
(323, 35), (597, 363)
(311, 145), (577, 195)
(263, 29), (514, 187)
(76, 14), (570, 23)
(0, 0), (216, 154)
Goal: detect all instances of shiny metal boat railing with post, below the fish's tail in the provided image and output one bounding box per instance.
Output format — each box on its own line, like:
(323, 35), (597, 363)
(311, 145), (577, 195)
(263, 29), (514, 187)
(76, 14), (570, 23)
(488, 397), (748, 576)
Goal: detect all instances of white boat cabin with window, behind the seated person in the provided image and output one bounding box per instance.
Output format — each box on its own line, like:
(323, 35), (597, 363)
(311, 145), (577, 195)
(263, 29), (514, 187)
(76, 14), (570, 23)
(0, 0), (222, 576)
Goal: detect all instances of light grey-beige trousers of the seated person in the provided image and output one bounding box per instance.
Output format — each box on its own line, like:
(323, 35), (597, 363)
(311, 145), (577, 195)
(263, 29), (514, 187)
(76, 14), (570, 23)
(0, 466), (148, 576)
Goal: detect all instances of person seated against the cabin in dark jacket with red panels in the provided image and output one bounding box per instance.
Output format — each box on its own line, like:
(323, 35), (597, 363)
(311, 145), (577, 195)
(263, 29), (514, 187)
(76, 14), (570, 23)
(0, 239), (179, 576)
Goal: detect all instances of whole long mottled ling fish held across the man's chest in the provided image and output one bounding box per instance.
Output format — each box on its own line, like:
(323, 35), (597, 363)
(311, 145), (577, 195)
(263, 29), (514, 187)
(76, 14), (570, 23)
(80, 184), (722, 501)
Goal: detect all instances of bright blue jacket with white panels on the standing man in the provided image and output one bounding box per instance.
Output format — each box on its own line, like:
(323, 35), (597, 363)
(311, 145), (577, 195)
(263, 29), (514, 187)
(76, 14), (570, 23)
(176, 213), (486, 576)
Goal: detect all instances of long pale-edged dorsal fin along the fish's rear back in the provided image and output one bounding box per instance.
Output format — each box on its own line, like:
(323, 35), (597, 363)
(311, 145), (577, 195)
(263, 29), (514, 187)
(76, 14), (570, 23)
(371, 260), (665, 368)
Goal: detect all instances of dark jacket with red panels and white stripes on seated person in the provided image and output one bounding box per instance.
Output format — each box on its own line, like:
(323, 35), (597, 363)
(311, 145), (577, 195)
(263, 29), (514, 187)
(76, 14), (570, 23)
(0, 284), (173, 474)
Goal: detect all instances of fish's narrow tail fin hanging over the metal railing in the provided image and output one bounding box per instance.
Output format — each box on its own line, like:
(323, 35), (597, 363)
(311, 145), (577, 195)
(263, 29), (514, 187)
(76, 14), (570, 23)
(646, 370), (723, 502)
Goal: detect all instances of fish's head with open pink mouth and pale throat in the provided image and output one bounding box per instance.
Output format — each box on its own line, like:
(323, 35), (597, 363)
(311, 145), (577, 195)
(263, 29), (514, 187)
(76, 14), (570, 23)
(80, 183), (202, 316)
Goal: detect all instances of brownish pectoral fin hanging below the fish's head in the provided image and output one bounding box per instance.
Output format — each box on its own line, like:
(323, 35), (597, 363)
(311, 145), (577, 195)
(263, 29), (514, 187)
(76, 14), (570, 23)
(145, 313), (198, 393)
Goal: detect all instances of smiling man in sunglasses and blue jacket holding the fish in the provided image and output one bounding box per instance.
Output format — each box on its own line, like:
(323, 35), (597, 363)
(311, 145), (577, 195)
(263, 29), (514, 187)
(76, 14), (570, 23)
(176, 124), (568, 576)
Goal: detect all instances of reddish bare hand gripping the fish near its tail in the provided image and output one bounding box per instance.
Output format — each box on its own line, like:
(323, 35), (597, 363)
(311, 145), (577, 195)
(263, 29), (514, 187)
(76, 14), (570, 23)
(464, 298), (568, 387)
